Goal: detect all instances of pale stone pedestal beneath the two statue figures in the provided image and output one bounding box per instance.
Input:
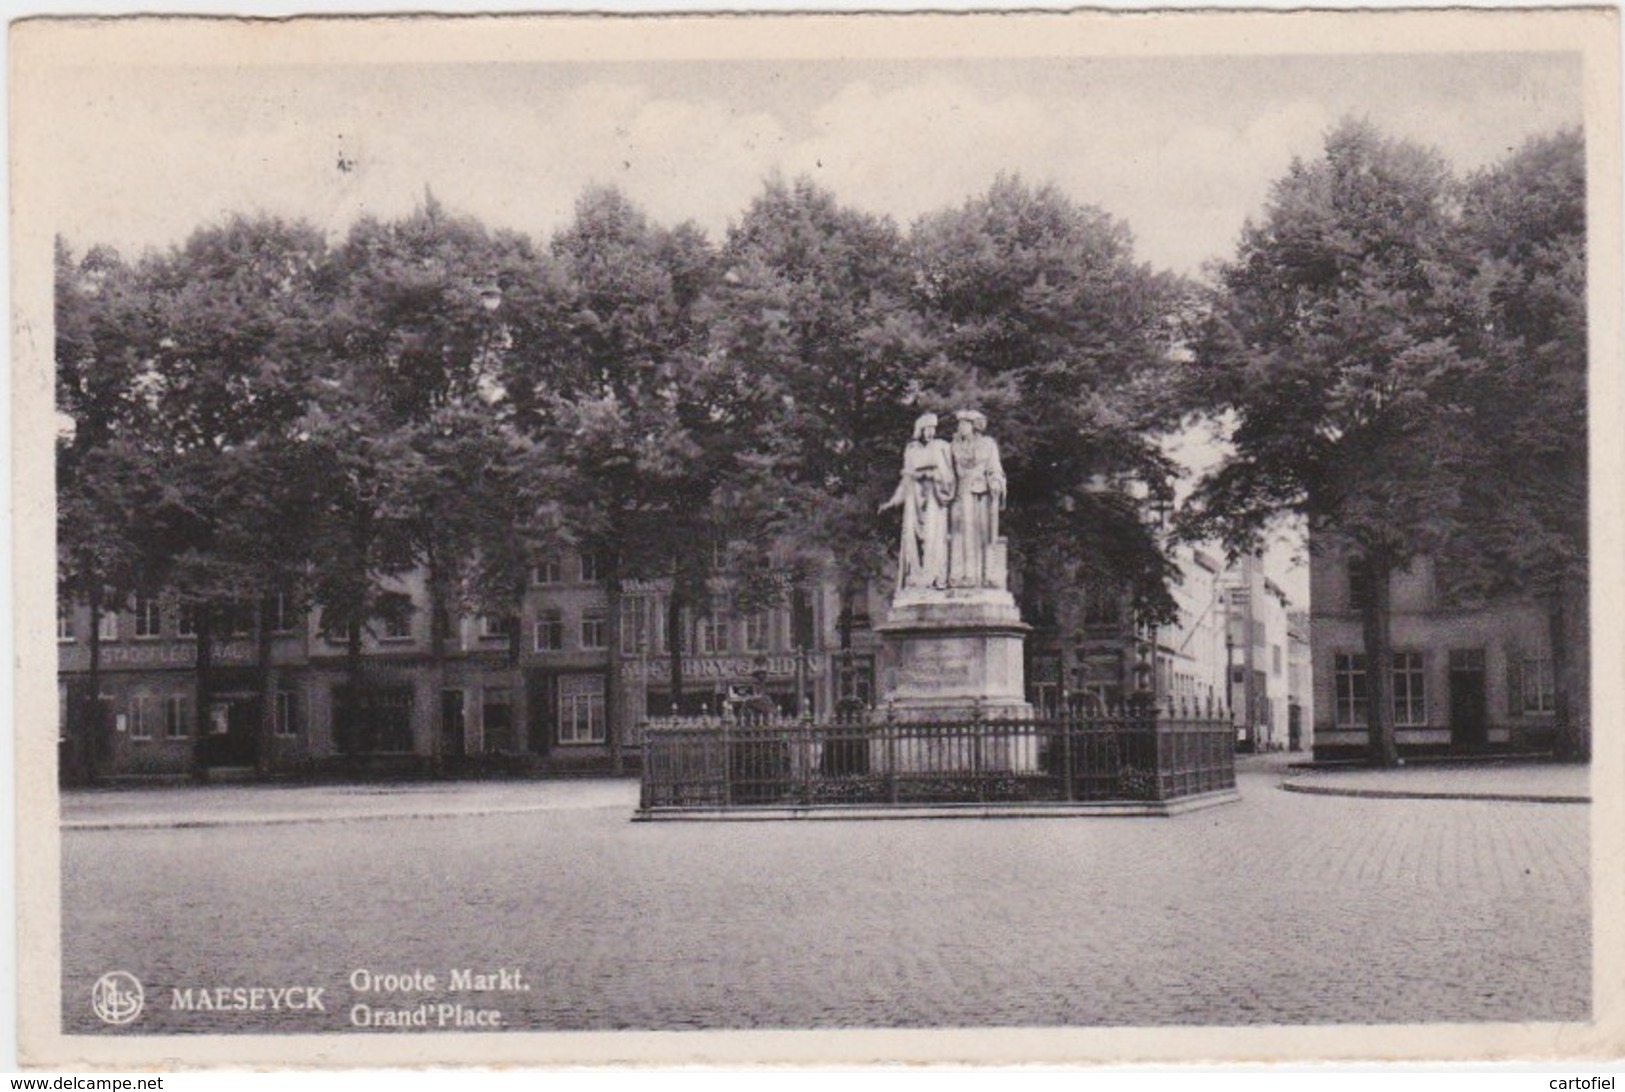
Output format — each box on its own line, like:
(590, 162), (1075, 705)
(874, 588), (1038, 774)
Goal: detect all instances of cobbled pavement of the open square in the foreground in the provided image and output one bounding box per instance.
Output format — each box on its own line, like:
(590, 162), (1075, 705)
(63, 764), (1589, 1034)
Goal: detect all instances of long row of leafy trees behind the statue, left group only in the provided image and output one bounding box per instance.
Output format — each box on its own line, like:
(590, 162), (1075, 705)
(57, 179), (1181, 776)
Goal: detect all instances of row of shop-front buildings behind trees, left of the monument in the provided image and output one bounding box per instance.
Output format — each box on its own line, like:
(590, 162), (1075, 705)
(57, 553), (882, 778)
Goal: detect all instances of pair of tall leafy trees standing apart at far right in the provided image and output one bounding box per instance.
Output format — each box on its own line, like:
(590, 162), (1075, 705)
(1185, 122), (1589, 765)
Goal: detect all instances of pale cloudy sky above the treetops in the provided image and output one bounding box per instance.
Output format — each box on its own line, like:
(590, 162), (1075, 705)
(49, 54), (1581, 273)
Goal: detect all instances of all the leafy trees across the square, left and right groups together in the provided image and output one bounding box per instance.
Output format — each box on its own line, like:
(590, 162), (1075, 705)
(57, 124), (1586, 773)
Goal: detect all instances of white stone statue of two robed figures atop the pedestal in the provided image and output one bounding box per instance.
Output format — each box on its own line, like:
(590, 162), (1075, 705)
(881, 410), (1006, 592)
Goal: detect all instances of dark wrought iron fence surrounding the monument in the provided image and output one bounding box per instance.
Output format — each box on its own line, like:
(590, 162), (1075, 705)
(642, 707), (1235, 811)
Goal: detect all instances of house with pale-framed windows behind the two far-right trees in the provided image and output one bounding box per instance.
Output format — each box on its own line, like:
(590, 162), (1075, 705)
(1310, 543), (1557, 759)
